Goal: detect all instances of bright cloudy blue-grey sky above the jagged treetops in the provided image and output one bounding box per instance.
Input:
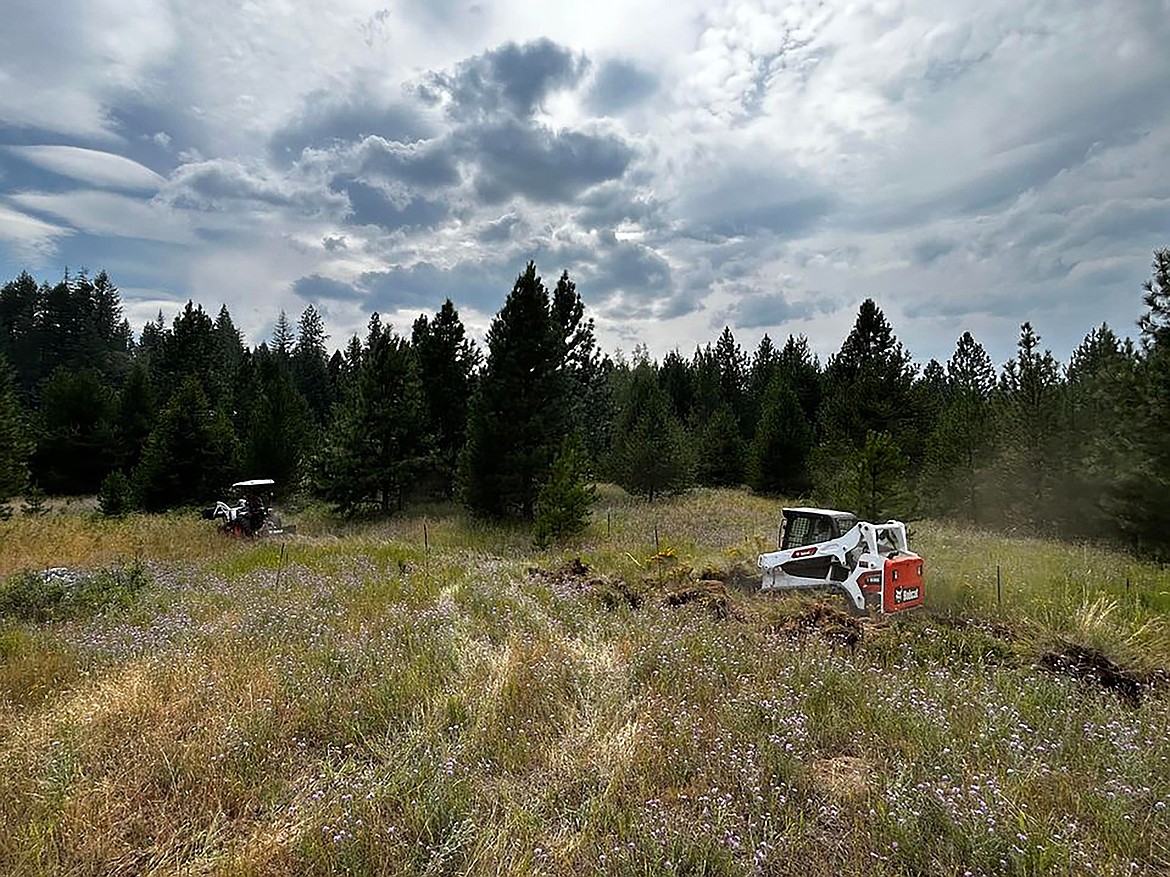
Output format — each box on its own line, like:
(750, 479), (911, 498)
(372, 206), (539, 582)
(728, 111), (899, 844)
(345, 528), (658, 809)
(0, 0), (1170, 364)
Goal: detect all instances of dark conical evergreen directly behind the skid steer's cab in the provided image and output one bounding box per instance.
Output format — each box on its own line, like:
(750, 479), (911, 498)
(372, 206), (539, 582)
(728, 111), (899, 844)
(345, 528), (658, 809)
(748, 372), (814, 496)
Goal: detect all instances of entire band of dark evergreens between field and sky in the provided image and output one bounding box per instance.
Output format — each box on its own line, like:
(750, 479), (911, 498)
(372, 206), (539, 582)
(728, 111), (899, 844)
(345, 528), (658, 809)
(0, 249), (1170, 553)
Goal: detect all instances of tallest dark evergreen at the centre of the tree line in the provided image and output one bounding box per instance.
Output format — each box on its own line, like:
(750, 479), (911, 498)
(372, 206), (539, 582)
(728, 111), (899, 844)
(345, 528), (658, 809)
(460, 262), (591, 520)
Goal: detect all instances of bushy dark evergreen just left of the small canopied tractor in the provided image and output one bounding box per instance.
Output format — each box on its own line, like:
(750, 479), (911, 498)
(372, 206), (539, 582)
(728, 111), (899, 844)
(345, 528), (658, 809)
(133, 374), (239, 511)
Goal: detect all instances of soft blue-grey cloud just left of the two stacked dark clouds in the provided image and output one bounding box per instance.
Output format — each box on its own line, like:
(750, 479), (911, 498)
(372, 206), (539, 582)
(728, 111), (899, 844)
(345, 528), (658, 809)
(268, 88), (434, 163)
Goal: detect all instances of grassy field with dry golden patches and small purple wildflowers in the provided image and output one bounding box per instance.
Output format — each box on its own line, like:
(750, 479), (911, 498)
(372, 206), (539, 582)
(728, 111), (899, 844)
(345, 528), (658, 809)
(0, 489), (1170, 877)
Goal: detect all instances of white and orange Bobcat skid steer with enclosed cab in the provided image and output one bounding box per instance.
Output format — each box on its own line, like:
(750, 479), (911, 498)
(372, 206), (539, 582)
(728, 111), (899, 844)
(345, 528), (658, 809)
(758, 509), (925, 614)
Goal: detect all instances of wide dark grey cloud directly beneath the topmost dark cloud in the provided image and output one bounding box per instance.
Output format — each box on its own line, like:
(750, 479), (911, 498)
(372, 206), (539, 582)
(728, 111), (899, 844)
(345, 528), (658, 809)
(467, 122), (634, 203)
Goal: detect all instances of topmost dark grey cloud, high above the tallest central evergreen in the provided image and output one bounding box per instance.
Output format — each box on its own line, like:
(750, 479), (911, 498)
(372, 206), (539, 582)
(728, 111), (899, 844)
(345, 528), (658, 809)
(417, 39), (589, 122)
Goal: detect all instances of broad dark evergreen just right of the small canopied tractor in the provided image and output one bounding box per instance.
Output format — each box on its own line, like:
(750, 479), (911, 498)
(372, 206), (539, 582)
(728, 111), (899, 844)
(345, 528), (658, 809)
(318, 315), (431, 515)
